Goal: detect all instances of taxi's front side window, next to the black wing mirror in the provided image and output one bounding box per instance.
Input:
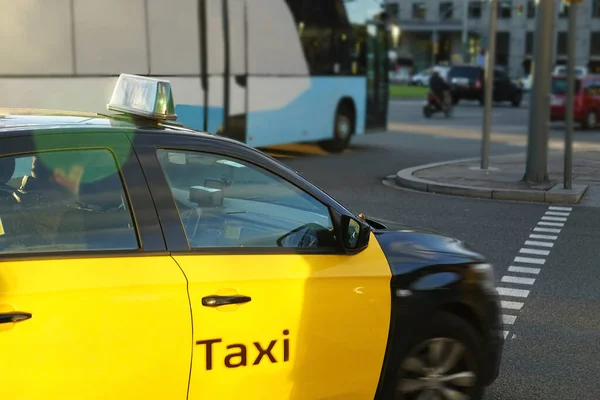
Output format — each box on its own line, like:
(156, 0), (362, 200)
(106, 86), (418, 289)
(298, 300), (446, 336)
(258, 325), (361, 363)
(157, 149), (337, 250)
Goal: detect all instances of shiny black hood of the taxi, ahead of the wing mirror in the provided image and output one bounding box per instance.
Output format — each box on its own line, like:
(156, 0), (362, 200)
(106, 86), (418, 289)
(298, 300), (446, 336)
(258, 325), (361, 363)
(364, 216), (485, 267)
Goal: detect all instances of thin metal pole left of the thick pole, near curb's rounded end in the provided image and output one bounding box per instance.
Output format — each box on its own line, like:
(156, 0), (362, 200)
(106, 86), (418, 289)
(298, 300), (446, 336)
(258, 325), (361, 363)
(481, 0), (498, 169)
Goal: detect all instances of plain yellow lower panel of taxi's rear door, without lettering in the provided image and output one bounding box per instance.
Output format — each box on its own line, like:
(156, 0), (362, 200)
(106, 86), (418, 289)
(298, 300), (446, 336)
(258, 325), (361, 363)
(0, 256), (192, 400)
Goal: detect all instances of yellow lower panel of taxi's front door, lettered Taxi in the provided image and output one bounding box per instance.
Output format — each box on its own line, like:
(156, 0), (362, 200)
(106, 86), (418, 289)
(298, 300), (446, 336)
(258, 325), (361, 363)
(174, 234), (391, 400)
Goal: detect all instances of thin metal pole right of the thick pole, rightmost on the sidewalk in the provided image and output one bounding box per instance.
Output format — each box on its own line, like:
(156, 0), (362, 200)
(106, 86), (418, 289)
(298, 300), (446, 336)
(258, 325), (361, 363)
(564, 3), (577, 189)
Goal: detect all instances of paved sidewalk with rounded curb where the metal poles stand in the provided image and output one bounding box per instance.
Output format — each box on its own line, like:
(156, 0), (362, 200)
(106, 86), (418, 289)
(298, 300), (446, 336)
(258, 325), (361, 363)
(395, 150), (600, 206)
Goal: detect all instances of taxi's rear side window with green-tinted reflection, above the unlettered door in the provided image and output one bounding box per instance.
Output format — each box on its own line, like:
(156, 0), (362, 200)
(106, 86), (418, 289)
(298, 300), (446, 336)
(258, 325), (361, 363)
(0, 150), (139, 254)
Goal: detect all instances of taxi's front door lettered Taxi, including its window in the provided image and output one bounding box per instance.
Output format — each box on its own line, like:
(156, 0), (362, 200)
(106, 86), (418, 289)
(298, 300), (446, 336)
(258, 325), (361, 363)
(137, 137), (391, 400)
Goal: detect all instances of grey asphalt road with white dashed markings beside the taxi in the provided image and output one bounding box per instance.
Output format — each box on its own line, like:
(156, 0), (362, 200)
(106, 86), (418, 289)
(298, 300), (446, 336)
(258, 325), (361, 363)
(270, 102), (600, 400)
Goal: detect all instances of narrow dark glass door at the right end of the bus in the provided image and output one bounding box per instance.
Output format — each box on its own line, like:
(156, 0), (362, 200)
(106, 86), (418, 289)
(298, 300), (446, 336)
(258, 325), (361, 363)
(366, 21), (389, 130)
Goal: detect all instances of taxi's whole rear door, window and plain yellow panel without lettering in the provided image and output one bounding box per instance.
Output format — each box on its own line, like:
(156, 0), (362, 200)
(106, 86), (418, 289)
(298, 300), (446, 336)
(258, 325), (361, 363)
(0, 134), (192, 400)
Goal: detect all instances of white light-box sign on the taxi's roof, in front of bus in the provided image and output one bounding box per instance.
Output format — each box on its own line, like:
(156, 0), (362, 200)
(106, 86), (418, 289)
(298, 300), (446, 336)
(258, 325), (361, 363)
(107, 74), (177, 120)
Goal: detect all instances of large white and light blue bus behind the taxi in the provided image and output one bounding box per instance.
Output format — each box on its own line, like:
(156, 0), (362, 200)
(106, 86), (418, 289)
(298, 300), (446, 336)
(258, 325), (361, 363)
(0, 0), (389, 151)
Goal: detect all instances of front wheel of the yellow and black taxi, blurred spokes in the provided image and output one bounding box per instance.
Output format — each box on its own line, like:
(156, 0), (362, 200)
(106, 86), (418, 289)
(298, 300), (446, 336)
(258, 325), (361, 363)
(394, 313), (485, 400)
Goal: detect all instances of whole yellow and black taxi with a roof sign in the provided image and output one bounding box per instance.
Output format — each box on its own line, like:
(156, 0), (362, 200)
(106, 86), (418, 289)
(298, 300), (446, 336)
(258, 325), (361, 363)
(0, 75), (503, 400)
